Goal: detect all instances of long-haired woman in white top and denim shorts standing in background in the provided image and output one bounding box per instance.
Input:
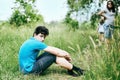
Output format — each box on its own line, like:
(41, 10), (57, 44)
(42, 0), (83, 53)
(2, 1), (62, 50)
(98, 0), (115, 47)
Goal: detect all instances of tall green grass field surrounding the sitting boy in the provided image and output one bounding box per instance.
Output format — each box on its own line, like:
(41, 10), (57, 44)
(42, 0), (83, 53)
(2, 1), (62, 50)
(0, 24), (120, 80)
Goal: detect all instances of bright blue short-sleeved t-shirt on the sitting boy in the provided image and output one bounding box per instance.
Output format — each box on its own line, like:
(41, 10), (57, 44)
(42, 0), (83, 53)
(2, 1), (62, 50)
(19, 37), (47, 73)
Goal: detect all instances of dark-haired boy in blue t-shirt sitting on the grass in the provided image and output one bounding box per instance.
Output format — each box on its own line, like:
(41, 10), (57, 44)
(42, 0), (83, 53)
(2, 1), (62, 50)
(19, 26), (83, 77)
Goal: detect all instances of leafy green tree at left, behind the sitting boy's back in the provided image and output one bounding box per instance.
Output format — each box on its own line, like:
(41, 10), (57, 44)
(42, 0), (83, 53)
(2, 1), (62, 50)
(9, 0), (44, 26)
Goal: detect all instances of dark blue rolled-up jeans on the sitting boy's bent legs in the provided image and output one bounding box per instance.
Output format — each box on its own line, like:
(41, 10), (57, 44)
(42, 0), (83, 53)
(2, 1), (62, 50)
(31, 52), (56, 74)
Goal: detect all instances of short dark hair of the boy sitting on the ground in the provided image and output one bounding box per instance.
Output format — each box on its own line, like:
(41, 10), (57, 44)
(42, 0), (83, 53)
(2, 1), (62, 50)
(33, 26), (49, 36)
